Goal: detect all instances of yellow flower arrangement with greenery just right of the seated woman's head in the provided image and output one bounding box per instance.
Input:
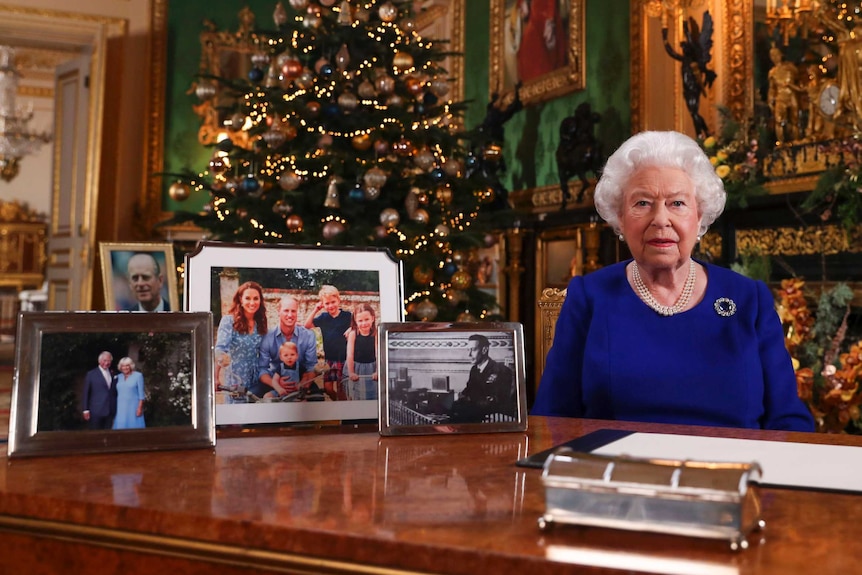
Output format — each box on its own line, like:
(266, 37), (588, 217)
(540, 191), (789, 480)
(700, 106), (766, 208)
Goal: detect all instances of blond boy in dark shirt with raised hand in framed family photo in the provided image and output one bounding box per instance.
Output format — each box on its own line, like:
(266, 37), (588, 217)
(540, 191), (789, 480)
(305, 285), (353, 401)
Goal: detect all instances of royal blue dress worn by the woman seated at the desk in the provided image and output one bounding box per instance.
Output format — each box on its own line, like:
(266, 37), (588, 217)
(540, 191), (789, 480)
(531, 262), (814, 431)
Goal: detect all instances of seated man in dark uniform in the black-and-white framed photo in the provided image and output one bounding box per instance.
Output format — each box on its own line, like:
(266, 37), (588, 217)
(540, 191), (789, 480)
(452, 334), (517, 423)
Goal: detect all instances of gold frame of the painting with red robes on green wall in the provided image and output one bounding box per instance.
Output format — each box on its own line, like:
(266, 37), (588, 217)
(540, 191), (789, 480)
(488, 0), (586, 104)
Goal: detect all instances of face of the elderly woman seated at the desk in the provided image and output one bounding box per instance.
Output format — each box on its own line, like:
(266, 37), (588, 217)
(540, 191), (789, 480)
(620, 166), (701, 268)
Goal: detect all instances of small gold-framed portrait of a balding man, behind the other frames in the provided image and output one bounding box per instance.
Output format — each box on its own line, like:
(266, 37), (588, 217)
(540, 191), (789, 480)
(99, 242), (182, 311)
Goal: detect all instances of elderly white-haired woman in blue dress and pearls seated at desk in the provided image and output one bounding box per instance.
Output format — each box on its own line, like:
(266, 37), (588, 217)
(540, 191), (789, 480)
(531, 132), (814, 431)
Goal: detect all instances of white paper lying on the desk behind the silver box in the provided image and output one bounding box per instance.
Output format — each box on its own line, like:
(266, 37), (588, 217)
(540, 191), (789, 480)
(593, 433), (862, 493)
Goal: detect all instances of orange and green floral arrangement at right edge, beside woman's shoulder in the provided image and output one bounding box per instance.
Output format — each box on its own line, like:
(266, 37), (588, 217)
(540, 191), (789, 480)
(777, 278), (862, 433)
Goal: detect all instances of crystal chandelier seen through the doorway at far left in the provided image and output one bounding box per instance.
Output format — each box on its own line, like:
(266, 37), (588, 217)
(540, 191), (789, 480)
(0, 46), (51, 182)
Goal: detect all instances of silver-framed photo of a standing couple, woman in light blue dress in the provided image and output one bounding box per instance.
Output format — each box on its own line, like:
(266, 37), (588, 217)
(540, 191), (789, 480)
(8, 312), (215, 457)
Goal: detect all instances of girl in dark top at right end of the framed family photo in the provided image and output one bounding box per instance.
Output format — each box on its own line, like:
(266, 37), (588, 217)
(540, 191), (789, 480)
(345, 303), (377, 400)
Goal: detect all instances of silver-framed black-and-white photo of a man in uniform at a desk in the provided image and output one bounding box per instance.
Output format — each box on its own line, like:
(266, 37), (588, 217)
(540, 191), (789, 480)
(379, 322), (527, 435)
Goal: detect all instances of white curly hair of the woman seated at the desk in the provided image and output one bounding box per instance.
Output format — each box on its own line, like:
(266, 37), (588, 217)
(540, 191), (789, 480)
(594, 131), (727, 236)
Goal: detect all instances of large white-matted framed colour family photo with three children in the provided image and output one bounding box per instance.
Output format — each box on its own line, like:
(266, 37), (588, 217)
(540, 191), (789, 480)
(185, 241), (404, 425)
